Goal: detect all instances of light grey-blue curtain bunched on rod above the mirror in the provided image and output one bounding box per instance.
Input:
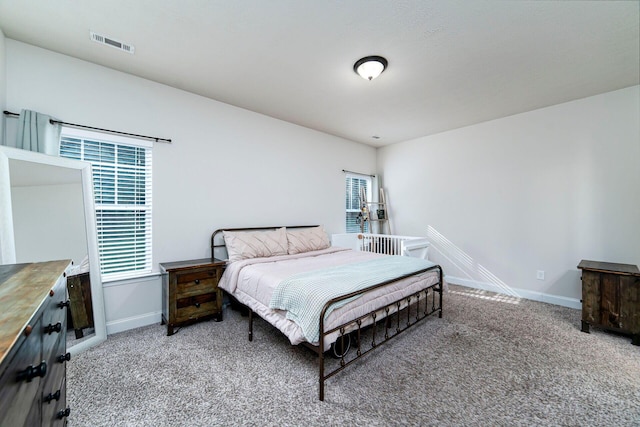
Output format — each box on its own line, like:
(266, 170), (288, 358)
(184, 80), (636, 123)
(15, 110), (61, 156)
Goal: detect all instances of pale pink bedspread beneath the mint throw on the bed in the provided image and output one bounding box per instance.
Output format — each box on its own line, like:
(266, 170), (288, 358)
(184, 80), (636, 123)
(219, 247), (439, 349)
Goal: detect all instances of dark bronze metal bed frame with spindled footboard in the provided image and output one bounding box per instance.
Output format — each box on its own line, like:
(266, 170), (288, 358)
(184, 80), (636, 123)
(211, 225), (443, 401)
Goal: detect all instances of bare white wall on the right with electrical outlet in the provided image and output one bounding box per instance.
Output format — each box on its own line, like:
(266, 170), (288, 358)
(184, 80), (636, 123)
(378, 86), (640, 307)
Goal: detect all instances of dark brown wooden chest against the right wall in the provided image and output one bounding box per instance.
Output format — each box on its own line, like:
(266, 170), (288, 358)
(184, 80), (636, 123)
(578, 260), (640, 345)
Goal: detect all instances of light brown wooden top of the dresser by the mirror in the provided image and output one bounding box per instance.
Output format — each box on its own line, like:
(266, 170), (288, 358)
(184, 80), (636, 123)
(0, 260), (71, 363)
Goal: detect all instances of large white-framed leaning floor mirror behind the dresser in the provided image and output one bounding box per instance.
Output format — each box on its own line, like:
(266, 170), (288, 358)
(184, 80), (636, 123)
(0, 146), (107, 355)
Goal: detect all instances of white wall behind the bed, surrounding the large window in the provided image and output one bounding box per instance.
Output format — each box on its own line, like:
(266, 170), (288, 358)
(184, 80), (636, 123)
(6, 39), (376, 332)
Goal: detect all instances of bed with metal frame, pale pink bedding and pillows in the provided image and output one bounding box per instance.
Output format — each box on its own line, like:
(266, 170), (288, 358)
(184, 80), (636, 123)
(211, 226), (443, 400)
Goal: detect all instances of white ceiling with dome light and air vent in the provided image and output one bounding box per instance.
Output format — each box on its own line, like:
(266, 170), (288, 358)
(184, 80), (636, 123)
(0, 0), (640, 146)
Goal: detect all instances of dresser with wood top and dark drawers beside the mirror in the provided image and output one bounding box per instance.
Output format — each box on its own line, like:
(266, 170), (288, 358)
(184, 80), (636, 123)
(0, 260), (71, 427)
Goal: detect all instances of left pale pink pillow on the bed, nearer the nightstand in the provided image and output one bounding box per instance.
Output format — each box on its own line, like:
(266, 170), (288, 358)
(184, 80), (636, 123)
(222, 227), (288, 262)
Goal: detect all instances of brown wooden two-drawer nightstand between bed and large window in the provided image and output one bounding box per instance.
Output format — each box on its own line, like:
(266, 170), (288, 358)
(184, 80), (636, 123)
(160, 258), (226, 335)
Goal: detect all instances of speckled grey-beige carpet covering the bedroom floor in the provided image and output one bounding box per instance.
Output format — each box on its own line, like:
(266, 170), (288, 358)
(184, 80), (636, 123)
(67, 286), (640, 426)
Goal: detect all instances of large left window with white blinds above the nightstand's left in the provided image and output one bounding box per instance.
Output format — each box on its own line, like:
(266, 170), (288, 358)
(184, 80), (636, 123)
(60, 128), (152, 282)
